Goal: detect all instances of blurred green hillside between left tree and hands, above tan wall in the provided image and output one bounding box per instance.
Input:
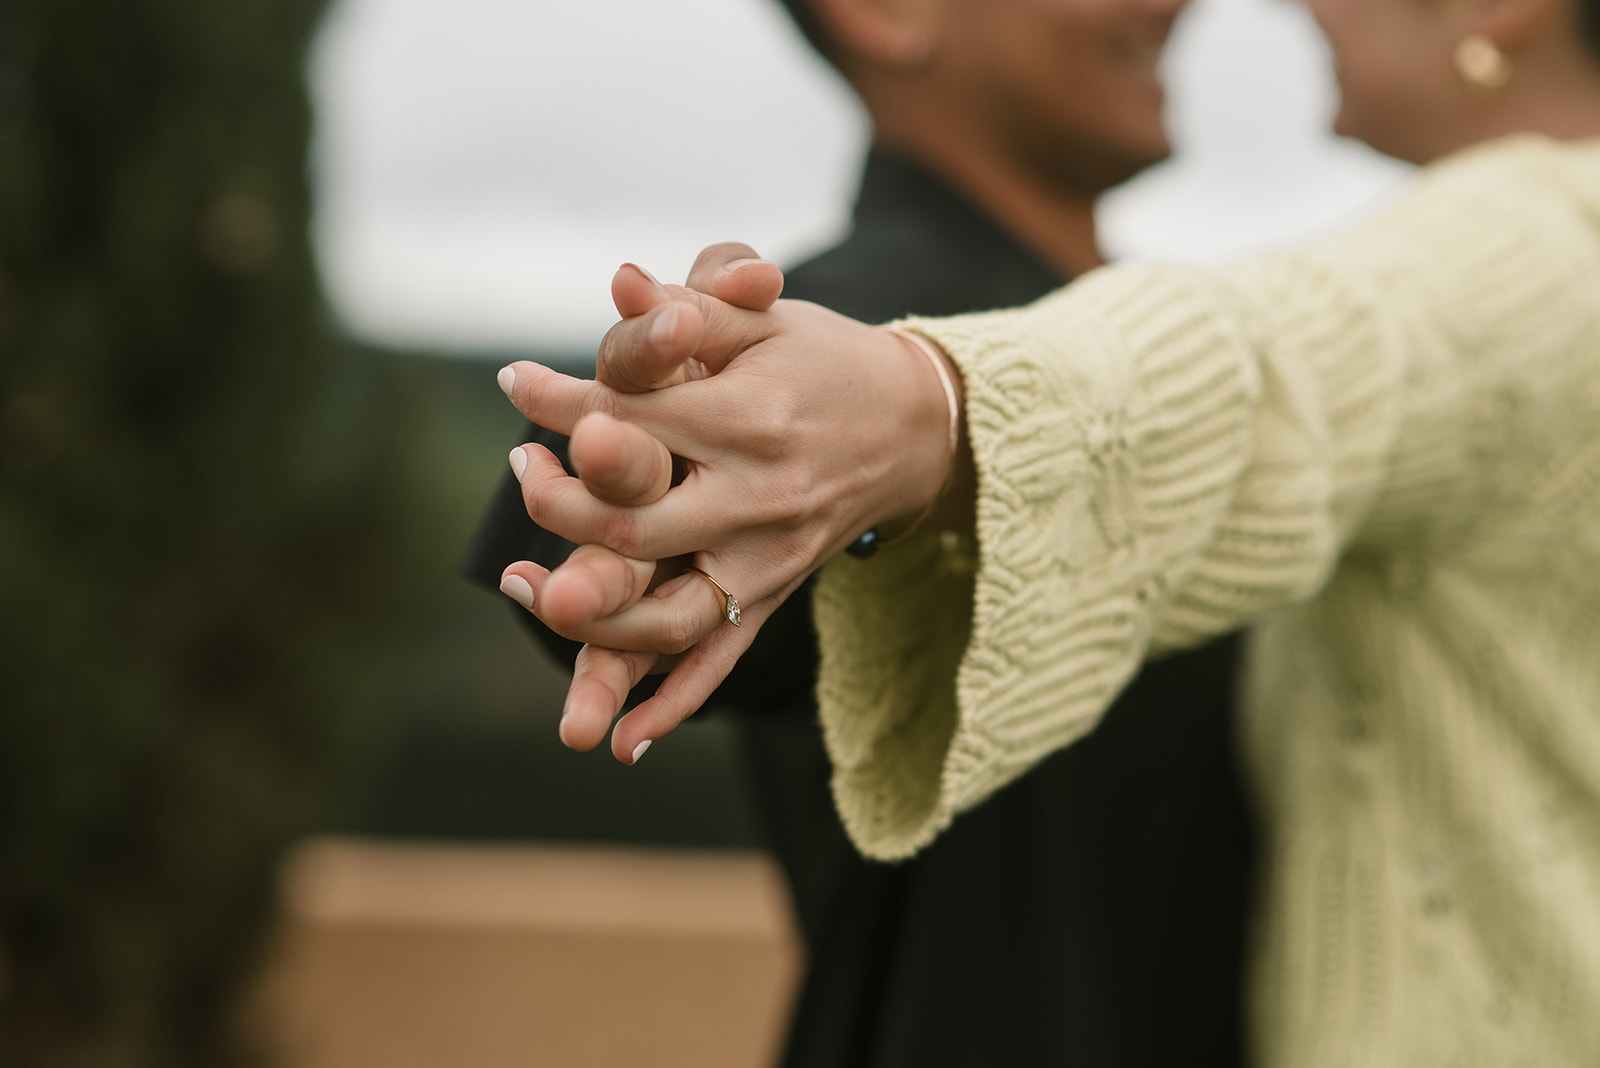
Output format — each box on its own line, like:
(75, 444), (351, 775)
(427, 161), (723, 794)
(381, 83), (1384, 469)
(330, 353), (757, 847)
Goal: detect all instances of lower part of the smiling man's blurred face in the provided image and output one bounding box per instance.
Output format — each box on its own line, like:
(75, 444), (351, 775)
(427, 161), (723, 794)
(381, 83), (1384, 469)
(941, 0), (1187, 193)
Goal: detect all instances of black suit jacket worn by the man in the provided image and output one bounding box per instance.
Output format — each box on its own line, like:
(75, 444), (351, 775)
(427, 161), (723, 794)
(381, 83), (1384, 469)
(469, 152), (1251, 1068)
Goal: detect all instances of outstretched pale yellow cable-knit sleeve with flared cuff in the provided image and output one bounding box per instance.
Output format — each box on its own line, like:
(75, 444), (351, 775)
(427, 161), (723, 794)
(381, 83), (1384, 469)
(816, 139), (1600, 859)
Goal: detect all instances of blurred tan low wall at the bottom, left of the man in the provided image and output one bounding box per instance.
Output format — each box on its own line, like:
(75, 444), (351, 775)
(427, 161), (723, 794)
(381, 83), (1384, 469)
(253, 839), (800, 1068)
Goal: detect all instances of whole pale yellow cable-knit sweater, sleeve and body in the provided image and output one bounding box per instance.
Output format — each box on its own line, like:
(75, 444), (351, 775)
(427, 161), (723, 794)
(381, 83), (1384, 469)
(816, 137), (1600, 1068)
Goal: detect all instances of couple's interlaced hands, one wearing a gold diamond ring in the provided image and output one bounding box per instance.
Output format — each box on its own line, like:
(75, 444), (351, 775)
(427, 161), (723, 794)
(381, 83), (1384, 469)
(502, 265), (970, 763)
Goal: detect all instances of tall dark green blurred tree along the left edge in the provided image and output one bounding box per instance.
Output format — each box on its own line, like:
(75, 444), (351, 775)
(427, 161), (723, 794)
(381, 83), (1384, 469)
(0, 0), (419, 1068)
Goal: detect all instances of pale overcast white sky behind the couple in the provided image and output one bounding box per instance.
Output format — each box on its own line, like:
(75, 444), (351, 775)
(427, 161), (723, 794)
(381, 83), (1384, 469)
(310, 0), (1405, 355)
